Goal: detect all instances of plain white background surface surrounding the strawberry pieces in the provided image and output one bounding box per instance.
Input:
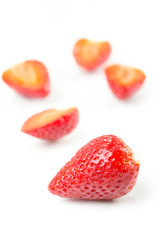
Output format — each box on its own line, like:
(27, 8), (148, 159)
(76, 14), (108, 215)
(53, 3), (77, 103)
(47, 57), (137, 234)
(0, 0), (160, 240)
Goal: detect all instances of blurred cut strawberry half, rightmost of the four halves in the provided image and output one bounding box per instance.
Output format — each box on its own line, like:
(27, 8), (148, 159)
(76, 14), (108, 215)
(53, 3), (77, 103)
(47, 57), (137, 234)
(105, 65), (146, 99)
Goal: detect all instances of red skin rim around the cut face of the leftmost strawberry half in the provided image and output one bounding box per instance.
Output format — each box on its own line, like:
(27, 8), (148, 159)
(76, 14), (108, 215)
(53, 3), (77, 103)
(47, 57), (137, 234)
(2, 60), (50, 98)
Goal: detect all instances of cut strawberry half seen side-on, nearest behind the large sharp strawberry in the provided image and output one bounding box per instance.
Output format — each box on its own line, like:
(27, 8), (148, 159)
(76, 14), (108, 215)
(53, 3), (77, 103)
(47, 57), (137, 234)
(21, 108), (79, 140)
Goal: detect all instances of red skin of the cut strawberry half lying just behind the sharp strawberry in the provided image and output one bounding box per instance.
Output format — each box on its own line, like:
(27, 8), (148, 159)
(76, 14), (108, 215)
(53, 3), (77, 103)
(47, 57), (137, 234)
(22, 109), (79, 141)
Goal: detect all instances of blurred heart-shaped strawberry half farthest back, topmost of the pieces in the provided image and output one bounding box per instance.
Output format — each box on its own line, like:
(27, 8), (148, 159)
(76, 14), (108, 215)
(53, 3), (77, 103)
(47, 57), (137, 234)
(73, 39), (111, 70)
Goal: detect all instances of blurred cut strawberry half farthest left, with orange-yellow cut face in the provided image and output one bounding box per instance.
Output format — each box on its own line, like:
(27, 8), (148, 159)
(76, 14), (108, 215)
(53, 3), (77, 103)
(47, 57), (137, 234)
(2, 60), (50, 97)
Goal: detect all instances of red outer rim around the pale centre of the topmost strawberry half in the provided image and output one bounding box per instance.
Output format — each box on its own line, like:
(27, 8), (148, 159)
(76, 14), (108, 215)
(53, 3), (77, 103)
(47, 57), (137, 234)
(73, 39), (111, 71)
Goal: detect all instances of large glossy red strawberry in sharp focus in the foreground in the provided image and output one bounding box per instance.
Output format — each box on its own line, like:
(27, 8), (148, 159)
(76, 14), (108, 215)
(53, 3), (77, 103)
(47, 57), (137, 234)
(48, 135), (139, 199)
